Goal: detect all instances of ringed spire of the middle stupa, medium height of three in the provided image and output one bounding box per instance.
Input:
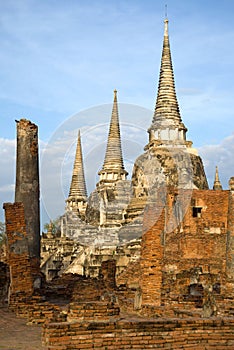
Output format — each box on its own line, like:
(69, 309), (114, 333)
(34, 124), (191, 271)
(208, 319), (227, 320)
(99, 90), (127, 179)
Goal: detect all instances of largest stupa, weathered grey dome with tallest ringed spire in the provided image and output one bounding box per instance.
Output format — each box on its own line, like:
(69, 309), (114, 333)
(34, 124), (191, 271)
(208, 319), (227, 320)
(123, 20), (208, 232)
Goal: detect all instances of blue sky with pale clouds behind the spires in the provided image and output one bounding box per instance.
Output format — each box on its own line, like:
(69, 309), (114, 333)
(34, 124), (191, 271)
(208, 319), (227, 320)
(0, 0), (234, 224)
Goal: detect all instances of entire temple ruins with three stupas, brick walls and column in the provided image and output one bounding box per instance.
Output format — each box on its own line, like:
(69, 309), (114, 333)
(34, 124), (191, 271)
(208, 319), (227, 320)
(0, 20), (234, 350)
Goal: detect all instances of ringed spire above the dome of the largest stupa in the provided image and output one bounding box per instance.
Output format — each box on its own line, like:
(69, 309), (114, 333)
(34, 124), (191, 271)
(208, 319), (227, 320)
(148, 18), (187, 141)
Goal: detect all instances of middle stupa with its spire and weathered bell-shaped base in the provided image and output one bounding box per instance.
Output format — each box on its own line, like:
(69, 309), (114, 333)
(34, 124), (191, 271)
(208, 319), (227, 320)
(87, 90), (130, 228)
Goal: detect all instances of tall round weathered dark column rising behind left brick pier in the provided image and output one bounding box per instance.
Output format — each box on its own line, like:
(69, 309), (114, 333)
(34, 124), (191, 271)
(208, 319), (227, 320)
(15, 119), (40, 259)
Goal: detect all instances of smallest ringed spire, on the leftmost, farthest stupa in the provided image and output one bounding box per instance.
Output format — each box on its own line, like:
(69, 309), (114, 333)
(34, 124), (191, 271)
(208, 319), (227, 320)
(67, 130), (87, 202)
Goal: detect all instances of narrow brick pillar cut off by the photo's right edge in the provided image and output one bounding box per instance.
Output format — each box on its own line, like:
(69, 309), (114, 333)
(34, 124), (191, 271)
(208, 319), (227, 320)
(226, 177), (234, 280)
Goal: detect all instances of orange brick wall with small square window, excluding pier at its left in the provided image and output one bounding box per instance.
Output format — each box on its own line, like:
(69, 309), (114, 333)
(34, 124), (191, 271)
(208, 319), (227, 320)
(162, 190), (231, 316)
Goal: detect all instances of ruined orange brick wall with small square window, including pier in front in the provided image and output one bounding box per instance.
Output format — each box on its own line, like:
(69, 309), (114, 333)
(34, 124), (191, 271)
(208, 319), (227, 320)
(136, 190), (234, 317)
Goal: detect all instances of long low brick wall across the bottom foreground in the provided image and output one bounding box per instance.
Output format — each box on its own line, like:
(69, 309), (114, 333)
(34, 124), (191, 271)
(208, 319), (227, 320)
(43, 318), (234, 350)
